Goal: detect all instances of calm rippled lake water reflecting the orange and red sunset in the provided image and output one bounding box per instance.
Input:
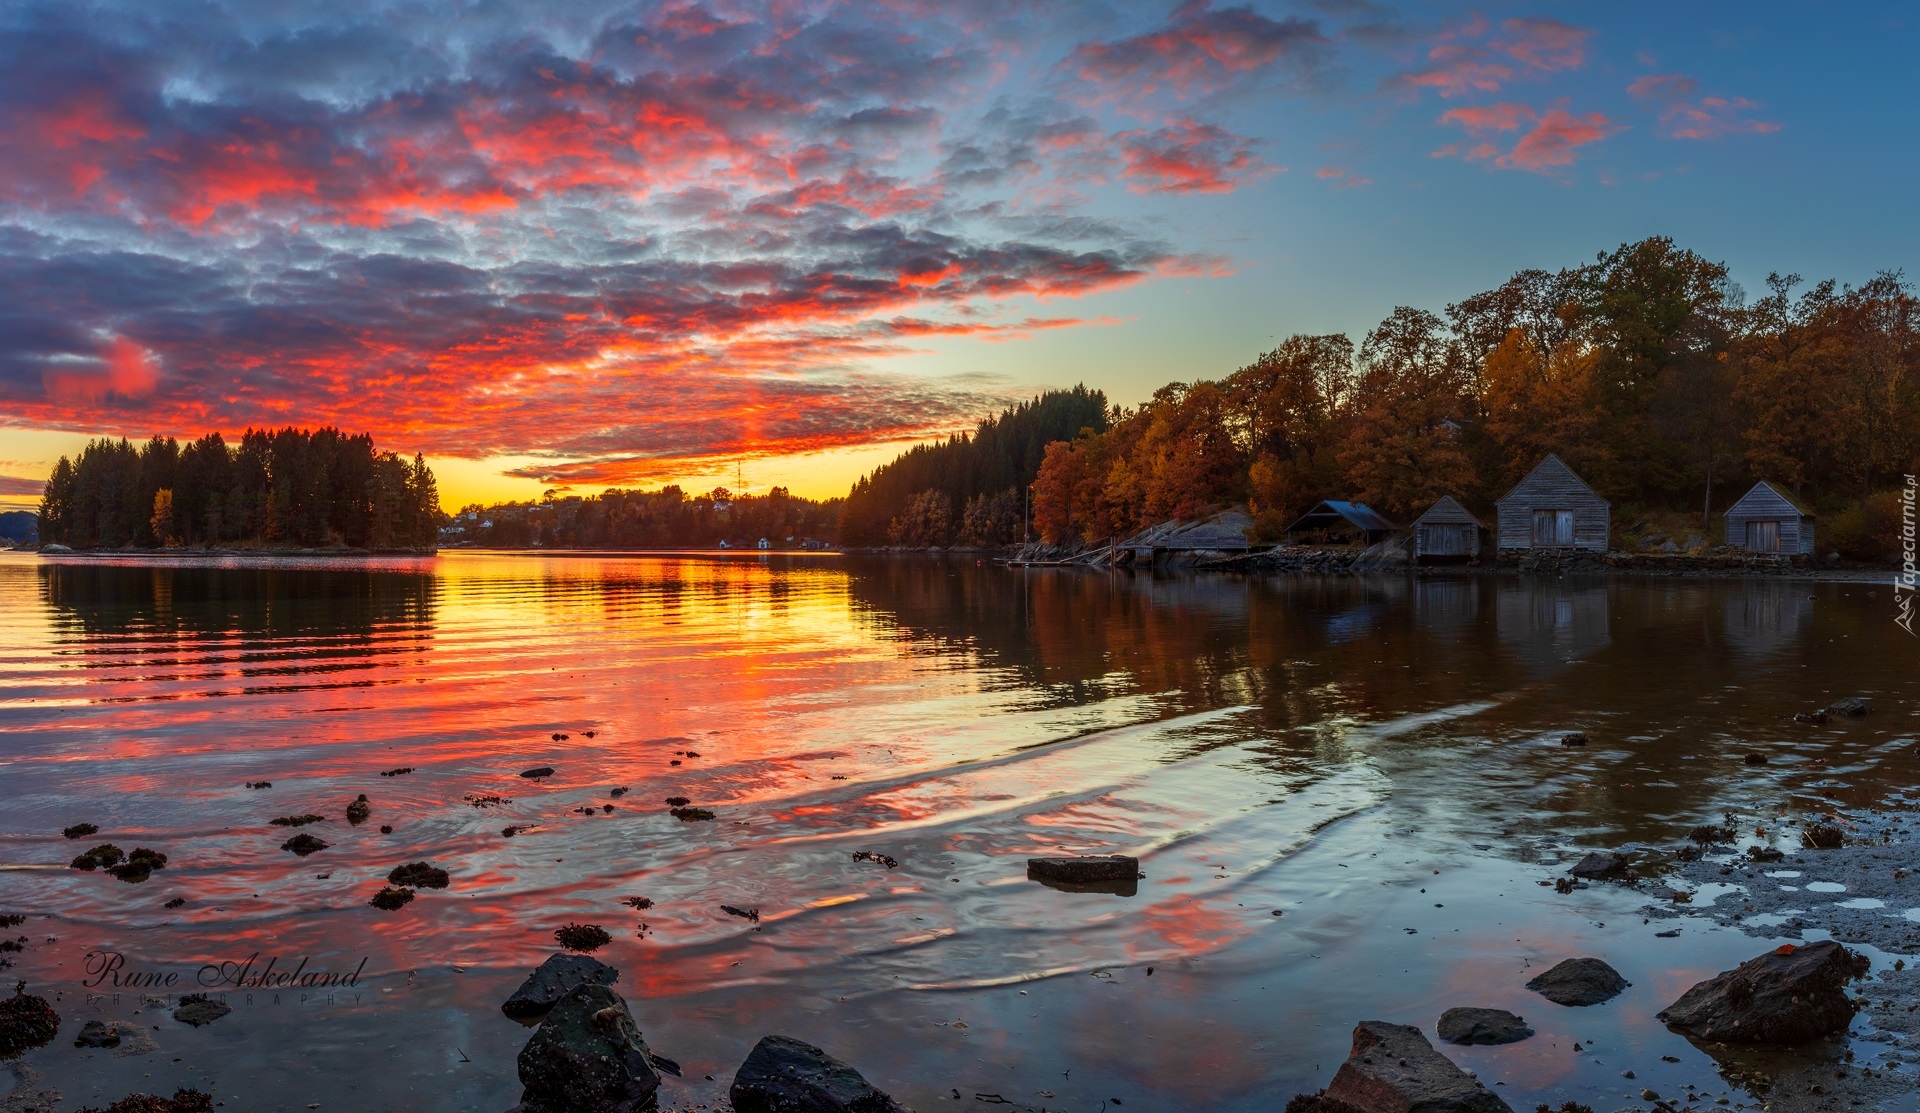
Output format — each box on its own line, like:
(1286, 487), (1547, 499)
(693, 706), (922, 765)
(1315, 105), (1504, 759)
(0, 553), (1920, 1113)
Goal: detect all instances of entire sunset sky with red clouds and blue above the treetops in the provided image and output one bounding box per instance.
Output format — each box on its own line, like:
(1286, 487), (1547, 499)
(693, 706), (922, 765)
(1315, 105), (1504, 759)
(0, 0), (1920, 509)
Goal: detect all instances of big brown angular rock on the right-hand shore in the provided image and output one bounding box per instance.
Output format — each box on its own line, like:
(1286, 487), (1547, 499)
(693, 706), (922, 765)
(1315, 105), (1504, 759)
(1659, 940), (1868, 1044)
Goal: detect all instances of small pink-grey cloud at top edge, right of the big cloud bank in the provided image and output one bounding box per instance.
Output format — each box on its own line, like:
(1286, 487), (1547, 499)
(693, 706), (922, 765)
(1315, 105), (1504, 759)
(1064, 0), (1327, 100)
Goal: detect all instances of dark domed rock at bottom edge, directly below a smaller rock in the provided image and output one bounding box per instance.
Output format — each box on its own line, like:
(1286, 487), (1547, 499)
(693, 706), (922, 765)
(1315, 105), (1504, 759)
(518, 984), (660, 1113)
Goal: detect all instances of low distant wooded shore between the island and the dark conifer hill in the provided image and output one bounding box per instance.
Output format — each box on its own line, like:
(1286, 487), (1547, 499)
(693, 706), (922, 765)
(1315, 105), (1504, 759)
(447, 487), (841, 549)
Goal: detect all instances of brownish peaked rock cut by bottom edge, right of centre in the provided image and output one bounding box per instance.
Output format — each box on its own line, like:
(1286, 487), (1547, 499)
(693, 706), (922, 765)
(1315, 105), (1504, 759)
(1286, 1021), (1513, 1113)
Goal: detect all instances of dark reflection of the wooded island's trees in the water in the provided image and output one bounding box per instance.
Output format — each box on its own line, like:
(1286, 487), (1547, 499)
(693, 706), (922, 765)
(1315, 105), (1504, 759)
(40, 562), (436, 641)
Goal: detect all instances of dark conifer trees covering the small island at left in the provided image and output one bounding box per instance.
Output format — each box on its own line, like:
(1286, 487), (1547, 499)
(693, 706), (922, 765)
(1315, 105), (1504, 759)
(40, 428), (444, 549)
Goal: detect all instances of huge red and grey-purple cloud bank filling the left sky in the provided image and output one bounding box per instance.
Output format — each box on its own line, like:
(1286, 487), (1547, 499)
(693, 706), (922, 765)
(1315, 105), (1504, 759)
(0, 0), (1323, 478)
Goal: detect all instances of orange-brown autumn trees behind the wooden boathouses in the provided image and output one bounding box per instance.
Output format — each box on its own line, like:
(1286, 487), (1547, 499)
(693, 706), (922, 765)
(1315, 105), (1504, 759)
(1021, 238), (1920, 557)
